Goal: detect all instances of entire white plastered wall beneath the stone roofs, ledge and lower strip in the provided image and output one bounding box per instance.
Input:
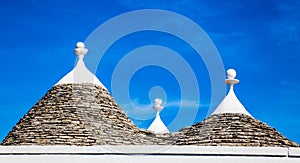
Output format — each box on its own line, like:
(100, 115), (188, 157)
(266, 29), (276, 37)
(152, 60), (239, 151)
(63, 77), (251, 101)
(0, 145), (300, 163)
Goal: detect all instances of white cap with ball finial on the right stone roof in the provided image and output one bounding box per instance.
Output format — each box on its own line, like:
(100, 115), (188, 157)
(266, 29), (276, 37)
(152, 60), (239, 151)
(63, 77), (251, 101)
(212, 69), (251, 116)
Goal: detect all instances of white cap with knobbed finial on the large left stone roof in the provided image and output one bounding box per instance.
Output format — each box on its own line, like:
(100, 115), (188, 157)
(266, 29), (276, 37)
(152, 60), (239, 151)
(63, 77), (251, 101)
(55, 42), (106, 89)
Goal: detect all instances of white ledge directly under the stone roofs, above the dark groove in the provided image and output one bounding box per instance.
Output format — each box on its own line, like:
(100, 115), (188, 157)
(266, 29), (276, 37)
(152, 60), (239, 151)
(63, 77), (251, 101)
(0, 145), (300, 158)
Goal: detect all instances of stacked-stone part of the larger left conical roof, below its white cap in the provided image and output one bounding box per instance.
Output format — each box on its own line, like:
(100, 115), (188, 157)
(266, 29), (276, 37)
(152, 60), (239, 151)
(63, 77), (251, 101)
(2, 84), (172, 145)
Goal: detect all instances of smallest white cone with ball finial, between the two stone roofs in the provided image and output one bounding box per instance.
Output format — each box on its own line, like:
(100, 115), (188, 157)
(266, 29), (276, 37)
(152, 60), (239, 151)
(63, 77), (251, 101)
(148, 98), (170, 133)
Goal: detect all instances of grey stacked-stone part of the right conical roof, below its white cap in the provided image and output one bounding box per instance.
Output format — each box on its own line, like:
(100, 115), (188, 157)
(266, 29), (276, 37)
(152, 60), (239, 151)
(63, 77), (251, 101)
(176, 113), (299, 147)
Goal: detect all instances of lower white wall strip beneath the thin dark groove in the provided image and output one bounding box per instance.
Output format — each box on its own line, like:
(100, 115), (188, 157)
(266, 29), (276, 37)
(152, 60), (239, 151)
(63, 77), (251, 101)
(0, 155), (299, 163)
